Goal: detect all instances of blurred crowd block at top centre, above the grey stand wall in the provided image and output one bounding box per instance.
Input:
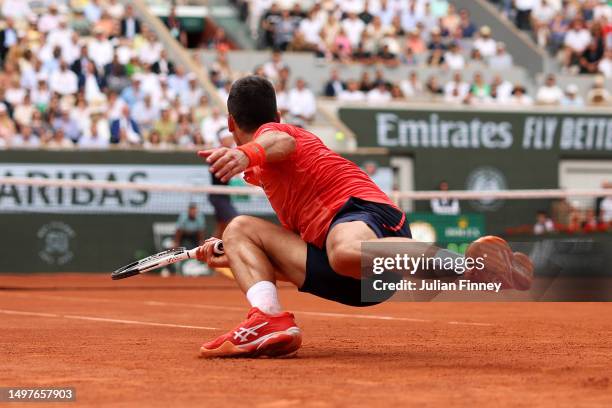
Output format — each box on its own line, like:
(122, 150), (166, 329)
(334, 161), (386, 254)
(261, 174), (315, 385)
(243, 0), (512, 69)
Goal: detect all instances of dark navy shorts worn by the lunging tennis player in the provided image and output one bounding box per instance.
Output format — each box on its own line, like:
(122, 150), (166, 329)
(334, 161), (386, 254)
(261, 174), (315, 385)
(299, 197), (412, 306)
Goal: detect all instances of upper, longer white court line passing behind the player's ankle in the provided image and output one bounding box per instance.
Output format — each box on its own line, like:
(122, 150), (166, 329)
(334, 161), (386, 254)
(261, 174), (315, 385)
(0, 293), (495, 327)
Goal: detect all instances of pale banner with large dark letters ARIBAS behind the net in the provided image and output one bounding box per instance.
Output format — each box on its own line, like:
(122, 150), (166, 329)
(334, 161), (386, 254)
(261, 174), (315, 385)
(0, 163), (272, 214)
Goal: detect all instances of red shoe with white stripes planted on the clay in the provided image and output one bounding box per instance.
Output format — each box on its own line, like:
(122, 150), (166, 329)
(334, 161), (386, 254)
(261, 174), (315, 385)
(200, 307), (302, 358)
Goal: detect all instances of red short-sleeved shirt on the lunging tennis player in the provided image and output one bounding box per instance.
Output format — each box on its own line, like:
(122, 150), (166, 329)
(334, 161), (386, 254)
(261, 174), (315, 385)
(245, 123), (397, 248)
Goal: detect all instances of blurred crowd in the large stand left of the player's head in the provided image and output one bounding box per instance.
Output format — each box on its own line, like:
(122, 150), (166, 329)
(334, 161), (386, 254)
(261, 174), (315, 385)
(0, 0), (220, 148)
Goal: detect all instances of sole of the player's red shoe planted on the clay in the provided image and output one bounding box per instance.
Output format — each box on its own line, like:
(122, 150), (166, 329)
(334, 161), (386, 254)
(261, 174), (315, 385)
(199, 327), (302, 358)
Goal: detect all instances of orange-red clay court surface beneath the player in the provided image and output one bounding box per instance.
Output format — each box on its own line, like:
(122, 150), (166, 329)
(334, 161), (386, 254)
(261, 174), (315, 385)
(0, 275), (612, 408)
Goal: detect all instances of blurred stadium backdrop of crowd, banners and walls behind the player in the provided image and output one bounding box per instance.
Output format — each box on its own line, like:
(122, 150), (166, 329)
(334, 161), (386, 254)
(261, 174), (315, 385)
(0, 0), (612, 275)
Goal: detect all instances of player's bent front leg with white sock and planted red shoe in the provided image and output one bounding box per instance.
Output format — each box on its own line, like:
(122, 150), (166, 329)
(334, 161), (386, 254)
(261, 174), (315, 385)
(200, 216), (306, 357)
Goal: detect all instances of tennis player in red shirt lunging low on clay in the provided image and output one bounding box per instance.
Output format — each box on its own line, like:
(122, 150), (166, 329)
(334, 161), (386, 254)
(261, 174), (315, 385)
(198, 76), (531, 357)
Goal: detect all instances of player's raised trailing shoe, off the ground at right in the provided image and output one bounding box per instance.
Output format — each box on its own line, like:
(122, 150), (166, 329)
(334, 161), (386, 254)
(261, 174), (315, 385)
(464, 235), (533, 290)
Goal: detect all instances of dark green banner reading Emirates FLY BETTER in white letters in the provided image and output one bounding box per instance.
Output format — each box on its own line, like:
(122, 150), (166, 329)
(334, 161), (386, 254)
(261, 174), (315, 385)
(340, 109), (612, 153)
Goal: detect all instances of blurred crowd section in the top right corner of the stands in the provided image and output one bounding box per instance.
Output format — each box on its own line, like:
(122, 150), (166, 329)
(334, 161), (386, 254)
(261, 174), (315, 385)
(492, 0), (612, 78)
